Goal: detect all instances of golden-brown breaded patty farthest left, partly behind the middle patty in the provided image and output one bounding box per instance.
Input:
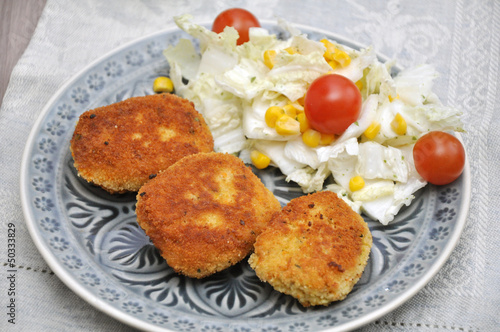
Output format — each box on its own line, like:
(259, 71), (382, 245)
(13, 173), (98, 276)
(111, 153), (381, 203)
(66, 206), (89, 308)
(70, 94), (214, 193)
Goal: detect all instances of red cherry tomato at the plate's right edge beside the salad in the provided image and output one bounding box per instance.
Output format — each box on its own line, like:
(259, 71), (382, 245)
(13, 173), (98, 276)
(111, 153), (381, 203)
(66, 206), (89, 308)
(413, 131), (465, 185)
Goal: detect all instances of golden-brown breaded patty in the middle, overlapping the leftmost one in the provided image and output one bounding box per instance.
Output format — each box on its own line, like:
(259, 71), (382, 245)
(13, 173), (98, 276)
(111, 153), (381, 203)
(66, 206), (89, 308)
(136, 152), (281, 278)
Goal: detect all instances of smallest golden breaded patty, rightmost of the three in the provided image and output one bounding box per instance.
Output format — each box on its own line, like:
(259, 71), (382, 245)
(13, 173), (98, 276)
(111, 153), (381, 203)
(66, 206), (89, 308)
(249, 191), (372, 306)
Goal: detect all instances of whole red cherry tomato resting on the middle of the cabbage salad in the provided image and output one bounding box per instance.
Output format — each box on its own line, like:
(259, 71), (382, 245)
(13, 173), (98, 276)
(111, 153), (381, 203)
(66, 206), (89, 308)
(304, 74), (362, 135)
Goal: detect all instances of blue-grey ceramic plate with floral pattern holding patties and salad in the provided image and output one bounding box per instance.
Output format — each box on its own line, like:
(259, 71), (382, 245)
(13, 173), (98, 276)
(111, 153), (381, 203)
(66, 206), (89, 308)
(21, 22), (470, 332)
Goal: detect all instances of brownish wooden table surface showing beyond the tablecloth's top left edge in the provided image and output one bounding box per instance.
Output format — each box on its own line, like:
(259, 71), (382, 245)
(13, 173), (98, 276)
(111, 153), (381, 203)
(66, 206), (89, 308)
(0, 0), (46, 104)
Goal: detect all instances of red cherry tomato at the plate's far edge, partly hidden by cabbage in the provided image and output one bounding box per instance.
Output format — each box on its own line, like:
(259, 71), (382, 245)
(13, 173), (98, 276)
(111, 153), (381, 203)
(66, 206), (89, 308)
(212, 8), (260, 45)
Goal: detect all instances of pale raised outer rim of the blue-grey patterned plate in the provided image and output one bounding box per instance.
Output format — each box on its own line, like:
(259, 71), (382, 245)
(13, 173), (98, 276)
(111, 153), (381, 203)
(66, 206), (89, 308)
(19, 19), (471, 331)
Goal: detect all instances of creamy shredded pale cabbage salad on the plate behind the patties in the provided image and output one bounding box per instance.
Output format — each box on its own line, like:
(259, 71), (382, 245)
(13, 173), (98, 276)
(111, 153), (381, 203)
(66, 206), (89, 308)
(164, 15), (463, 225)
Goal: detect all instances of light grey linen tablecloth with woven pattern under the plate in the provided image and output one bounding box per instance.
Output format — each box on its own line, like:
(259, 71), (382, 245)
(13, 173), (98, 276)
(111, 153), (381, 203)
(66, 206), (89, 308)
(0, 0), (500, 331)
